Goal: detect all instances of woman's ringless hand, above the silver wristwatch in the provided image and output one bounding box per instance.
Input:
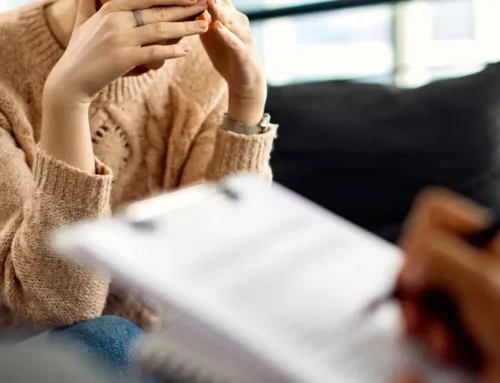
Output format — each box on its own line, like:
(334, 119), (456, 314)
(200, 0), (267, 126)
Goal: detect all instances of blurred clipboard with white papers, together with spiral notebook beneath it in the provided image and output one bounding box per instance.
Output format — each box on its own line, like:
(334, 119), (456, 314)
(53, 176), (475, 383)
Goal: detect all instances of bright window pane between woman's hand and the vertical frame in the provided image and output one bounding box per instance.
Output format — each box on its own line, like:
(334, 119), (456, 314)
(253, 5), (394, 84)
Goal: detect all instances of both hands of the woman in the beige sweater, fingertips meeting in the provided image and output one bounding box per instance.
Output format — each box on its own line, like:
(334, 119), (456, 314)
(45, 0), (267, 126)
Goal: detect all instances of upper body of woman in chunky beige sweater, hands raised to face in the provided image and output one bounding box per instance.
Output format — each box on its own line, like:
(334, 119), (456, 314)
(0, 0), (276, 328)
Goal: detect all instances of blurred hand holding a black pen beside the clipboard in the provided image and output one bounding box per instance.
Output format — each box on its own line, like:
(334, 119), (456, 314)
(394, 190), (500, 382)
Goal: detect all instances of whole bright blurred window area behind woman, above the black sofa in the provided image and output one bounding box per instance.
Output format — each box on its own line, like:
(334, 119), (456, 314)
(0, 0), (500, 87)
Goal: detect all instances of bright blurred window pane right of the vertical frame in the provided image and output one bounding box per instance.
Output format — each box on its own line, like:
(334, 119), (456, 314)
(395, 0), (500, 86)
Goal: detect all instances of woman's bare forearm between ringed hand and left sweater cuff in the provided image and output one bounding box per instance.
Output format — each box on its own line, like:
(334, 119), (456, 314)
(40, 91), (96, 174)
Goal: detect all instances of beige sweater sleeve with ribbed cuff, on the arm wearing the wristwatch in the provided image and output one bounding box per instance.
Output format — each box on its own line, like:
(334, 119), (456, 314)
(181, 91), (277, 184)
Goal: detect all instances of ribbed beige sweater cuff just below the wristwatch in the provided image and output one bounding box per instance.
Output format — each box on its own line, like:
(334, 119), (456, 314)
(210, 125), (278, 179)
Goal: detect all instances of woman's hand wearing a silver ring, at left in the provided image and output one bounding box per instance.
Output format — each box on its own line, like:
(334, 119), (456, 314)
(44, 0), (208, 105)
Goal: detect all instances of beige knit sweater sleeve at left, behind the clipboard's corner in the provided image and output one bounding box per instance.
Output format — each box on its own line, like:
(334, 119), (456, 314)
(0, 118), (112, 325)
